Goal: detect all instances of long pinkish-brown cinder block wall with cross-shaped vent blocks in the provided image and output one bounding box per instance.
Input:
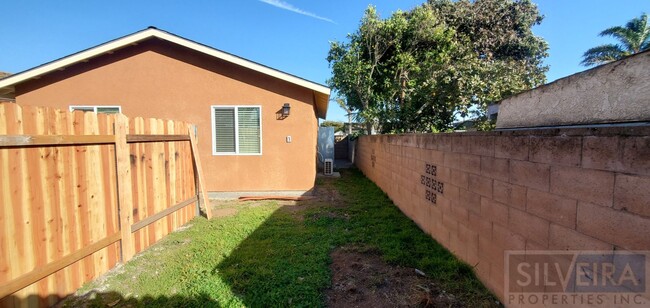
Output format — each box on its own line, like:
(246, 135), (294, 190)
(356, 127), (650, 297)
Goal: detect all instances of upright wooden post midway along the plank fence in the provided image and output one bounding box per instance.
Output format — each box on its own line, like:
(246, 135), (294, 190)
(115, 114), (135, 263)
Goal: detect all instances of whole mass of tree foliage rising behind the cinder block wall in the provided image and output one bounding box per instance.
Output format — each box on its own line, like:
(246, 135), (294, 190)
(327, 0), (547, 133)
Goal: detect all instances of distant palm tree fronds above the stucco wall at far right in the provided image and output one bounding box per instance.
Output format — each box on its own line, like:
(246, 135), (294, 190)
(580, 13), (650, 66)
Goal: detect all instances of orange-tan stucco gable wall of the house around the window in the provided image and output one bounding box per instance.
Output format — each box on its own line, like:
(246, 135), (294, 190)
(16, 41), (318, 191)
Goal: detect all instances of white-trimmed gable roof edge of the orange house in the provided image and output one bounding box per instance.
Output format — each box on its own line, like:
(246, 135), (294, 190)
(0, 27), (330, 119)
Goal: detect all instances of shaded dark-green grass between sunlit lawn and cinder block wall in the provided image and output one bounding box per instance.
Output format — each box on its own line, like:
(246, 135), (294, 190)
(213, 170), (497, 307)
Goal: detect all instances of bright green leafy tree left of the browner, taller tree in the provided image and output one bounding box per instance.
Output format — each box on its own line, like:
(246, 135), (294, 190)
(328, 6), (460, 134)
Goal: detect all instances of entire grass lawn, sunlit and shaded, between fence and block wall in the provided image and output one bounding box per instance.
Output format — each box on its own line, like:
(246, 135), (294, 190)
(64, 170), (495, 307)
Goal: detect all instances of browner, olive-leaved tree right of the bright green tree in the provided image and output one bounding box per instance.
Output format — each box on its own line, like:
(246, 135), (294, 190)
(427, 0), (548, 125)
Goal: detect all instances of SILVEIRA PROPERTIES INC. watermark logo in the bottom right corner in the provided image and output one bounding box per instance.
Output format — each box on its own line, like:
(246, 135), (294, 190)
(504, 251), (650, 307)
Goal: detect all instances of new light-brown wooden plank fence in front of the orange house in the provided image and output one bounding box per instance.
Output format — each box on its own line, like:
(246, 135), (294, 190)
(0, 103), (210, 307)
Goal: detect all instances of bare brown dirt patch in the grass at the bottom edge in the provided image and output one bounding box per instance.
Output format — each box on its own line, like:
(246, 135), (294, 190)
(326, 247), (463, 308)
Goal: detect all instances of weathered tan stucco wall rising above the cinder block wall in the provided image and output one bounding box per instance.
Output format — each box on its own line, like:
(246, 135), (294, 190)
(497, 51), (650, 128)
